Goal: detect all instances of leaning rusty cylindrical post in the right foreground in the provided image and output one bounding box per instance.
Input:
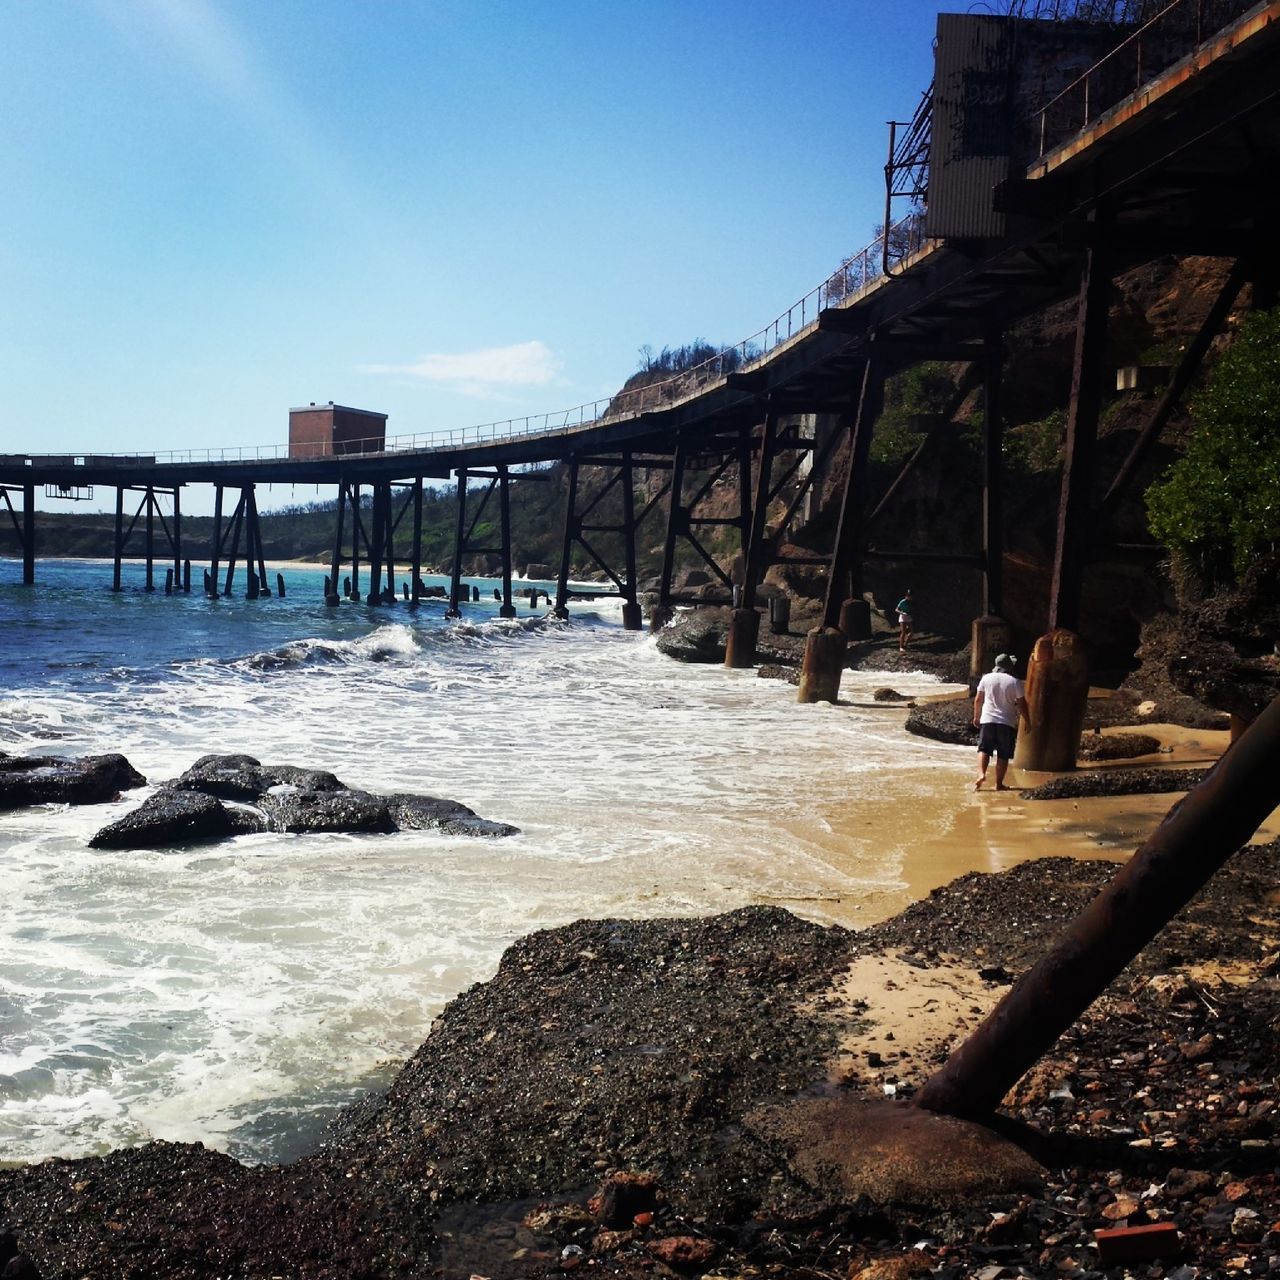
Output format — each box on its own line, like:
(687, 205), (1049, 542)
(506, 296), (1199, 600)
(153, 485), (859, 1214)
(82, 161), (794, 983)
(911, 698), (1280, 1119)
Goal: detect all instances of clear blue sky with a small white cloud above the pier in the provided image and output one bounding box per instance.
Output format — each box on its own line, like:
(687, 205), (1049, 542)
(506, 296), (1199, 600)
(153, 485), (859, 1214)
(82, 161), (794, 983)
(0, 0), (942, 502)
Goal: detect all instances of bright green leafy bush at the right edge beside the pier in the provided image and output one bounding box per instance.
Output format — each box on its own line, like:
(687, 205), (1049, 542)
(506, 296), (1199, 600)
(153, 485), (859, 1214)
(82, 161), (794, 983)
(1147, 308), (1280, 585)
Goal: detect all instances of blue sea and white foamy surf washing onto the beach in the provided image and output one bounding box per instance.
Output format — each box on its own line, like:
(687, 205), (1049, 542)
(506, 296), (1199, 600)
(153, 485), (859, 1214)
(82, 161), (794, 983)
(0, 559), (969, 1162)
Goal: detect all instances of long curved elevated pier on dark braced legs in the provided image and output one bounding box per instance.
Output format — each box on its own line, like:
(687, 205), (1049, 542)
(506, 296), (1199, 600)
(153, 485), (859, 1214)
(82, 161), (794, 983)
(0, 0), (1280, 660)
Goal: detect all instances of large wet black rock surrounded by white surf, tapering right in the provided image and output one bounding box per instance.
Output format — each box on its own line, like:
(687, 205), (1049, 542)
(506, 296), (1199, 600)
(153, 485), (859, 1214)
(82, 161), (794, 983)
(90, 755), (518, 849)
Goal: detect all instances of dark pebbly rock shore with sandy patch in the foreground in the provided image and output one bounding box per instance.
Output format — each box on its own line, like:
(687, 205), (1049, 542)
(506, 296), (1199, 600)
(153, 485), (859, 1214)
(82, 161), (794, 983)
(0, 845), (1280, 1280)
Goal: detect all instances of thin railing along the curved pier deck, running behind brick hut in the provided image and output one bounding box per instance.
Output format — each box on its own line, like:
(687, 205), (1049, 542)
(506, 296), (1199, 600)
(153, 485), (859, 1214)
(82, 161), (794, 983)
(5, 212), (923, 466)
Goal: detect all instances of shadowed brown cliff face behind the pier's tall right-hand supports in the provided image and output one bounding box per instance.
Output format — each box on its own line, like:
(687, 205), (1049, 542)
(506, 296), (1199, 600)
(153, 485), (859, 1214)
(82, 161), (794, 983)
(787, 249), (1248, 671)
